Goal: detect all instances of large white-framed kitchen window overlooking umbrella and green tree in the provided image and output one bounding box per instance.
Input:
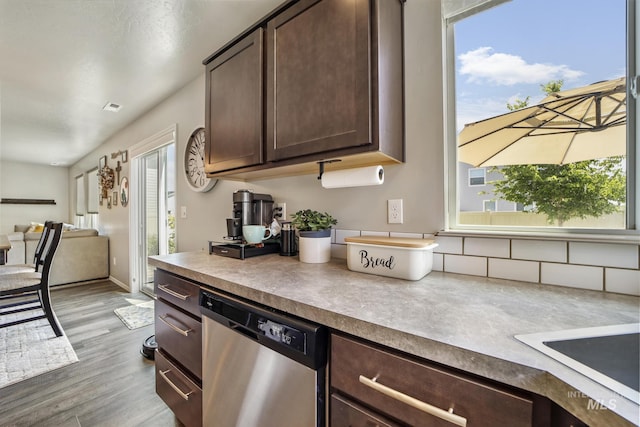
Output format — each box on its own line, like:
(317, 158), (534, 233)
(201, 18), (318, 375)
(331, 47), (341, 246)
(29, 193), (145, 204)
(441, 0), (638, 232)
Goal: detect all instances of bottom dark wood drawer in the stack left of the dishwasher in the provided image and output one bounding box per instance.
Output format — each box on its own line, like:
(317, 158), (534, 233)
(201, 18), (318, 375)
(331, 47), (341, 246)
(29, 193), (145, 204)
(155, 351), (202, 427)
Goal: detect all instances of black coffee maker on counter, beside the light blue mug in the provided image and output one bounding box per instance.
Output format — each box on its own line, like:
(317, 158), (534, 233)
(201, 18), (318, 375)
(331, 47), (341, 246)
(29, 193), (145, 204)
(226, 190), (273, 240)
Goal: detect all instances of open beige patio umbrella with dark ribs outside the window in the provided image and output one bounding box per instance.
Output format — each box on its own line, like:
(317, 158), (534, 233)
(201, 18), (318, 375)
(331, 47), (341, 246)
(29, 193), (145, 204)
(458, 77), (627, 167)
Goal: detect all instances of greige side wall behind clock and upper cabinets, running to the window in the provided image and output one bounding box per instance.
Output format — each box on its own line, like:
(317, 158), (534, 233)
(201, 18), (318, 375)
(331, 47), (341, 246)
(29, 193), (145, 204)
(68, 1), (444, 285)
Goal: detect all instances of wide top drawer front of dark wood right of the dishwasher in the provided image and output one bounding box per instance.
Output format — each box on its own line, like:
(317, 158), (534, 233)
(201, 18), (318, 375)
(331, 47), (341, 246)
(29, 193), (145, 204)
(330, 335), (533, 427)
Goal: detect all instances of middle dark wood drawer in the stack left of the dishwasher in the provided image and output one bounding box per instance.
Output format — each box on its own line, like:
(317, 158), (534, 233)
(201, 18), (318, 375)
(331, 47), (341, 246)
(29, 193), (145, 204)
(155, 300), (202, 379)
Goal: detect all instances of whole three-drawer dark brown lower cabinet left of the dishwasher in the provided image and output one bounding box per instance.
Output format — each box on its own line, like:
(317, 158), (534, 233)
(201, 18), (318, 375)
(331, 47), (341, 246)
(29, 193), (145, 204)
(155, 270), (202, 427)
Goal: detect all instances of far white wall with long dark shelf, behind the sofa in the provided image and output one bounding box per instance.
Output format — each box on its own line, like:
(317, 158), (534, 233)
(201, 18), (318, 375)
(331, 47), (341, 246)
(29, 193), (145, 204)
(0, 161), (73, 234)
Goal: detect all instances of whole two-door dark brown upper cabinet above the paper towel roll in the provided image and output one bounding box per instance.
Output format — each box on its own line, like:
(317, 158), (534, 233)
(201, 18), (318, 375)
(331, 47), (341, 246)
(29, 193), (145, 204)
(205, 0), (404, 179)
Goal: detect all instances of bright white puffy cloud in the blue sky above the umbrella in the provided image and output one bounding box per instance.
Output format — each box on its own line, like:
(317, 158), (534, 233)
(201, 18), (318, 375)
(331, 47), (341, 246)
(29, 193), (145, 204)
(458, 47), (584, 86)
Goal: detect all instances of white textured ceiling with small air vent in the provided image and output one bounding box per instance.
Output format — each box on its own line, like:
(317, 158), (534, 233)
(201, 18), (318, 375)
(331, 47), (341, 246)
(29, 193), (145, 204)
(0, 0), (283, 166)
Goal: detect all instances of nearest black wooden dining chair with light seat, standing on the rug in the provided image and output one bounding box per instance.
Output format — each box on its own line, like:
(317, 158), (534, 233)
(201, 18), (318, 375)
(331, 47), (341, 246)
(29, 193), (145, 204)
(0, 222), (63, 337)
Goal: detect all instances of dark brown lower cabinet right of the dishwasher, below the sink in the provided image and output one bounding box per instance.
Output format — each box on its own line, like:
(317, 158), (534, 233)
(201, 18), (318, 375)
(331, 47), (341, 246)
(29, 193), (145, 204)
(329, 334), (585, 427)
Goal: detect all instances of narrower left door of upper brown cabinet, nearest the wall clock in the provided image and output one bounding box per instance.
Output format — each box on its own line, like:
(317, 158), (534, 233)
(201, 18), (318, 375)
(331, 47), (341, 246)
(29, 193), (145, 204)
(205, 28), (264, 172)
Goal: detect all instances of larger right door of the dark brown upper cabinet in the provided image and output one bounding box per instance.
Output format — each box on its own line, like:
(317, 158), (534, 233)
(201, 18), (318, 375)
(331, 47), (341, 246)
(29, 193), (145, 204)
(266, 0), (372, 161)
